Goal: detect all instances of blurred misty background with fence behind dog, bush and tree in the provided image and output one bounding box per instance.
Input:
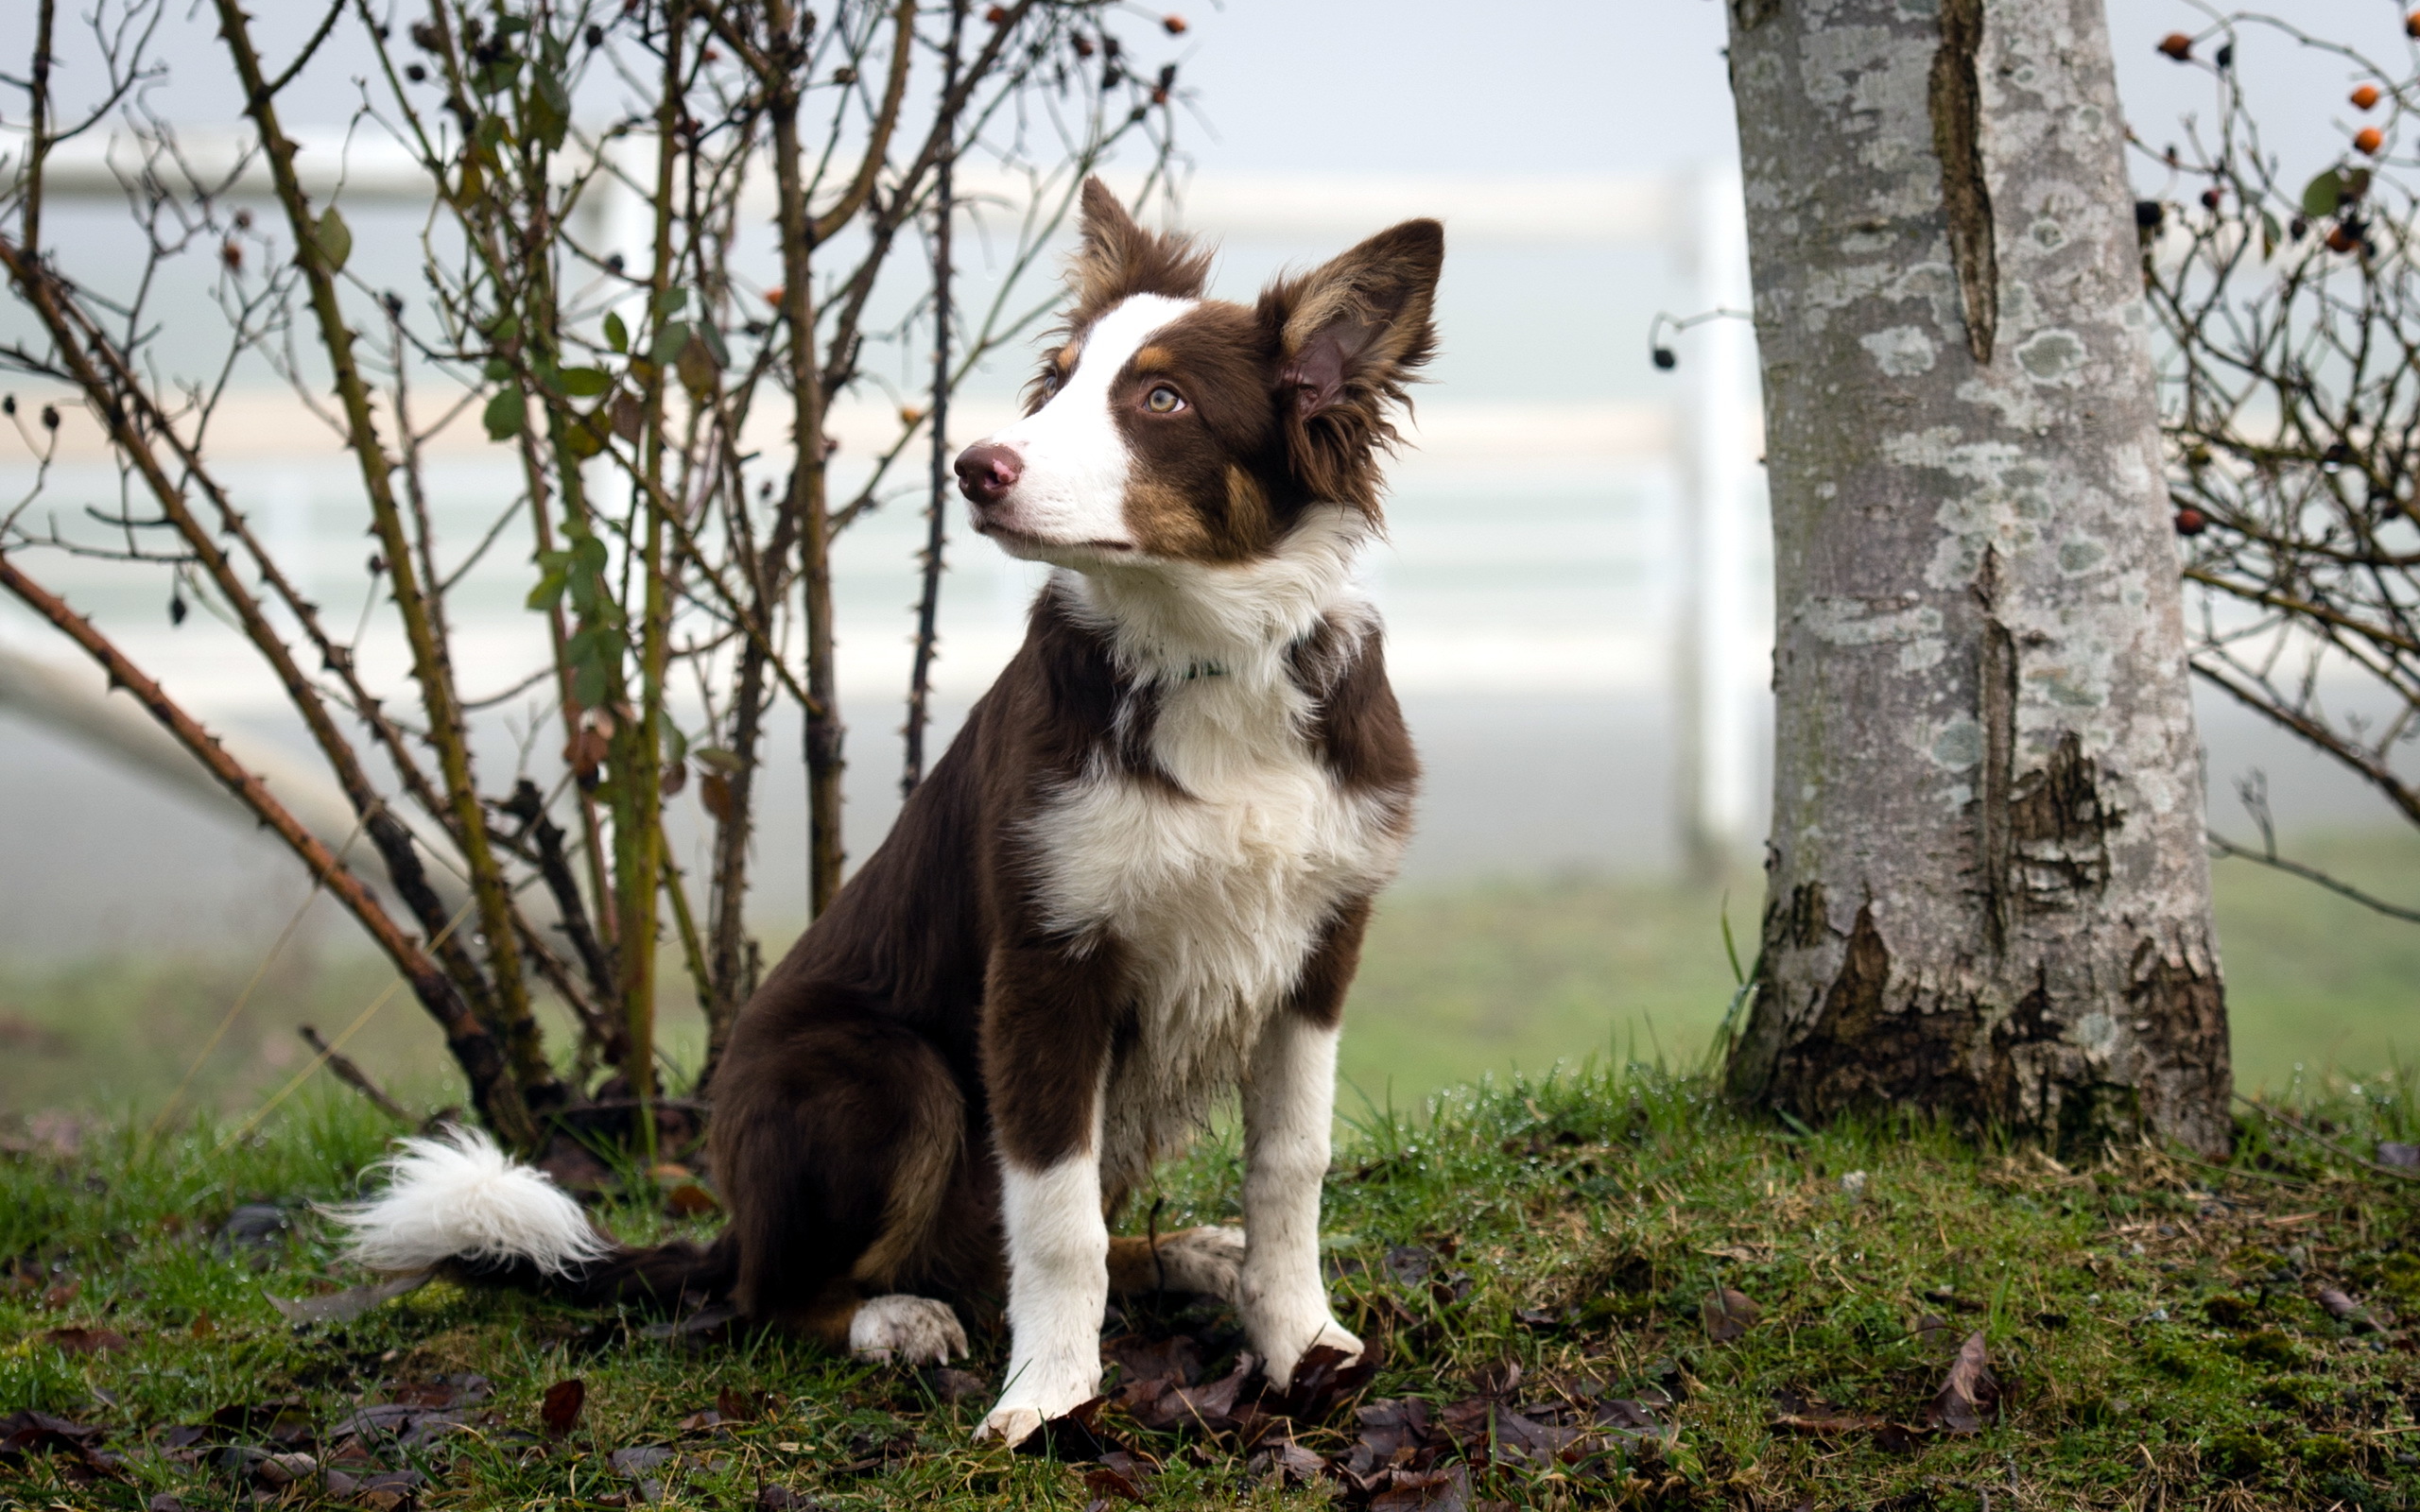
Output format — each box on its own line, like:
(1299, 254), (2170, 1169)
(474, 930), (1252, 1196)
(0, 0), (2420, 1113)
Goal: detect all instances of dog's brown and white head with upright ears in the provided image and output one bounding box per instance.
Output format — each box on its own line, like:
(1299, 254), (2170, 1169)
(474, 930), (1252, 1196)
(959, 179), (1444, 569)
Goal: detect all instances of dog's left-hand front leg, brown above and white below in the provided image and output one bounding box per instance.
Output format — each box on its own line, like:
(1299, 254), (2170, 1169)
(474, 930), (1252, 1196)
(976, 951), (1114, 1444)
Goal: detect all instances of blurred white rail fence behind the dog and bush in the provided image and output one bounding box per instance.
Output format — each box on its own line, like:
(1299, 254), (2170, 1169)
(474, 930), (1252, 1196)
(0, 138), (1772, 885)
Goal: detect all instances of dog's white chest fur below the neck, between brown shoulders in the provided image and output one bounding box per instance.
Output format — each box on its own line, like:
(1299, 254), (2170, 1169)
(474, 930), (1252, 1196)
(1033, 670), (1404, 1185)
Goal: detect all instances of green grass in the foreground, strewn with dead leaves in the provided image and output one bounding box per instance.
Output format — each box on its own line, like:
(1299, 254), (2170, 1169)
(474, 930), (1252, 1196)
(0, 1067), (2420, 1512)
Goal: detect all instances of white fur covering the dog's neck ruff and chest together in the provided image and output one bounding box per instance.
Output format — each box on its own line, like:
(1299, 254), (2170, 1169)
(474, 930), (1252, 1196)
(1031, 510), (1404, 1188)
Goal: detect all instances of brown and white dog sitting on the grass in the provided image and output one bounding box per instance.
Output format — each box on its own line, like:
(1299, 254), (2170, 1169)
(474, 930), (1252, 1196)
(349, 181), (1444, 1442)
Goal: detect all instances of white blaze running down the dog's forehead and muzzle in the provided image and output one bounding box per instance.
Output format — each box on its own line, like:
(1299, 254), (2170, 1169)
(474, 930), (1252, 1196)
(962, 295), (1201, 558)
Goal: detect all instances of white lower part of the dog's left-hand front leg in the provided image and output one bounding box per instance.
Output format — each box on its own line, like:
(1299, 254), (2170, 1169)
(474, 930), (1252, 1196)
(976, 1140), (1108, 1444)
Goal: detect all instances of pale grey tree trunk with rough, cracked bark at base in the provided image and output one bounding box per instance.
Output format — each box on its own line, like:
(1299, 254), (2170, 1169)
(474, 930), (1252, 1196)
(1730, 0), (2231, 1152)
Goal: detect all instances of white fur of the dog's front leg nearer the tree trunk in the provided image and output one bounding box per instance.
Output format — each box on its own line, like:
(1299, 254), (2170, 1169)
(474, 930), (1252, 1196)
(1236, 1014), (1362, 1388)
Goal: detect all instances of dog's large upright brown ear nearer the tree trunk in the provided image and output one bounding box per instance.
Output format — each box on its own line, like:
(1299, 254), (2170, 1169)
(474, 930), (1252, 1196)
(1261, 220), (1444, 515)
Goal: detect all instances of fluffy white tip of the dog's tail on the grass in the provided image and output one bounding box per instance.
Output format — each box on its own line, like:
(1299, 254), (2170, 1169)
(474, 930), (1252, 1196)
(329, 1125), (613, 1275)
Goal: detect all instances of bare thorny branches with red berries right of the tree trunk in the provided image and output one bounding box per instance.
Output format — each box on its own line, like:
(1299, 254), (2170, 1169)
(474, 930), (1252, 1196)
(2135, 9), (2420, 919)
